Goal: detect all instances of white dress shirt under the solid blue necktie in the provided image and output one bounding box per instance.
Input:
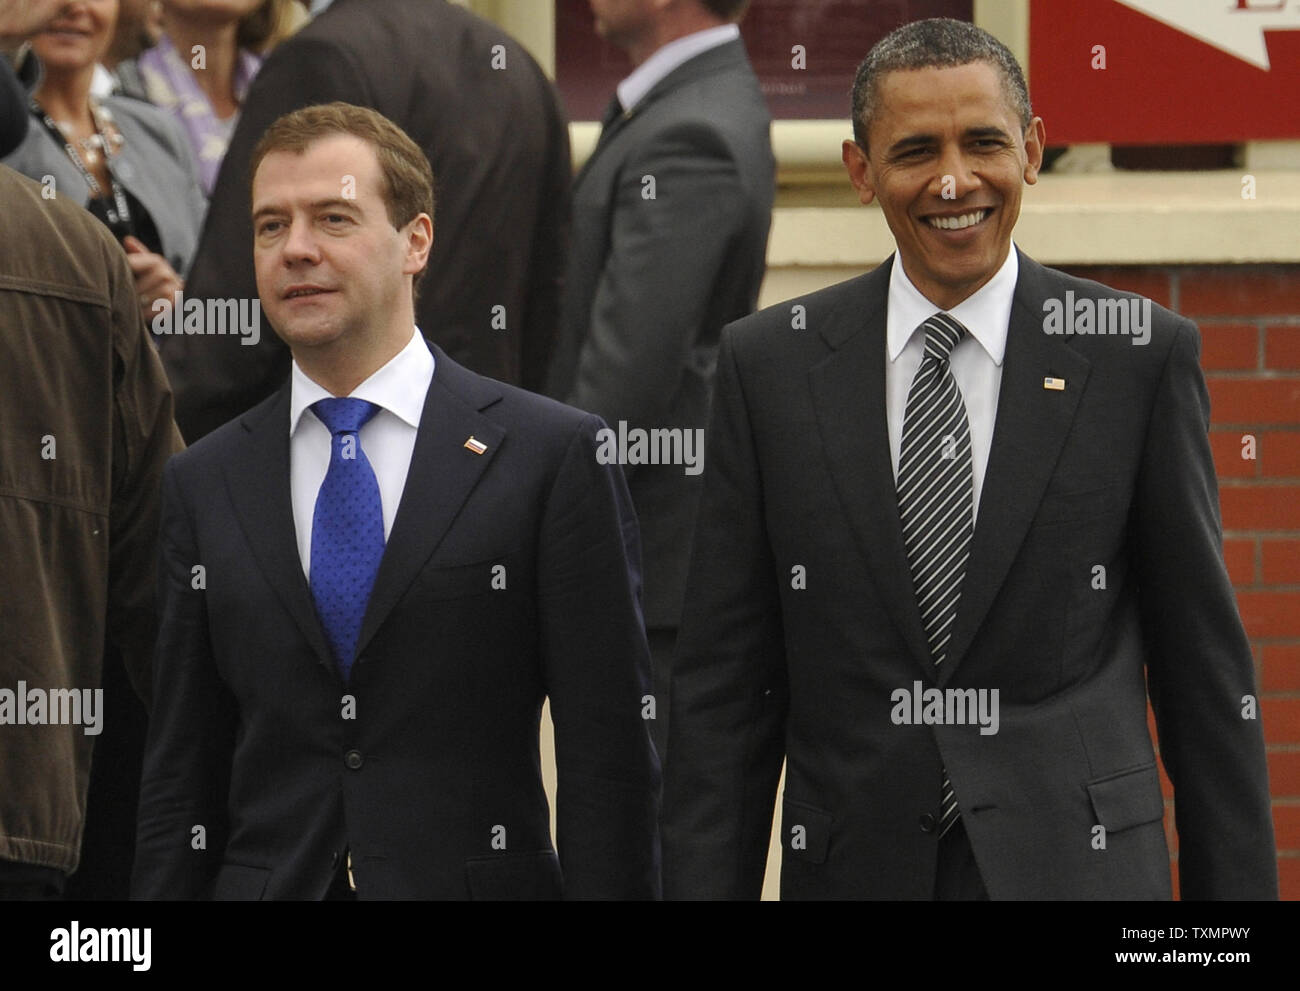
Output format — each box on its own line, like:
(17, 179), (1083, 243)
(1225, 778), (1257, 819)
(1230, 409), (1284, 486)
(289, 328), (433, 579)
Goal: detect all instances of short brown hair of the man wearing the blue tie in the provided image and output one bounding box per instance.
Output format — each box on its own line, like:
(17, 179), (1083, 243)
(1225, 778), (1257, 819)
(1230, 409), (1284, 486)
(248, 103), (434, 285)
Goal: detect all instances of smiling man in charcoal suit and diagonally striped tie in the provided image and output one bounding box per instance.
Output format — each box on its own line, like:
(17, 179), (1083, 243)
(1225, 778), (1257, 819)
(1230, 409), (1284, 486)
(663, 21), (1277, 900)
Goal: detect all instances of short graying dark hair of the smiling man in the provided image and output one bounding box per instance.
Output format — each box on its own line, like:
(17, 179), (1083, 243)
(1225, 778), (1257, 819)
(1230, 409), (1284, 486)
(853, 17), (1034, 151)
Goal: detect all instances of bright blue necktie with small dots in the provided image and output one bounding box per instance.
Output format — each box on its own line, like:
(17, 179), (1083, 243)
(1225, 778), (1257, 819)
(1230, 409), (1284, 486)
(311, 399), (384, 681)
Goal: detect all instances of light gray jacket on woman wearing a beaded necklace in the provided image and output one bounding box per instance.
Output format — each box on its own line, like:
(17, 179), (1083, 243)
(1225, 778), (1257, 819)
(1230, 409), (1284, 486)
(4, 96), (207, 276)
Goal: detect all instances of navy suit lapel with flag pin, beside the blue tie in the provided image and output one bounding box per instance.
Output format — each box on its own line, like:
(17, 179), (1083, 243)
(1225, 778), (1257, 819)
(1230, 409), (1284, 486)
(356, 345), (506, 655)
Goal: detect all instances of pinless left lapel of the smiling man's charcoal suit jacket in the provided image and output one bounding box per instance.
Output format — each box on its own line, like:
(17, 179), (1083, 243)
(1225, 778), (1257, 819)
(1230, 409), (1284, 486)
(809, 258), (933, 675)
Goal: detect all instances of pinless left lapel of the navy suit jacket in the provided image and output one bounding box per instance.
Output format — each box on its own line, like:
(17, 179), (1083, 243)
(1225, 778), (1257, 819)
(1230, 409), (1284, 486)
(225, 382), (337, 671)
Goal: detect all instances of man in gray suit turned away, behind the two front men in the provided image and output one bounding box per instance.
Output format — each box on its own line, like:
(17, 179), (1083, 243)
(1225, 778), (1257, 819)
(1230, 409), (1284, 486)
(547, 0), (775, 753)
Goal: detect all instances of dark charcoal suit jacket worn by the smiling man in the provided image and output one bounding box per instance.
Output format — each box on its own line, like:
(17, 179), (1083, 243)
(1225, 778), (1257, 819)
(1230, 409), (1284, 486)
(663, 247), (1278, 899)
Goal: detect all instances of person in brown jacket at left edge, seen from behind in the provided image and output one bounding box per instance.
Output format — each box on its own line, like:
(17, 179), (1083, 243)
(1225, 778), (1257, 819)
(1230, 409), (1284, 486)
(0, 159), (182, 900)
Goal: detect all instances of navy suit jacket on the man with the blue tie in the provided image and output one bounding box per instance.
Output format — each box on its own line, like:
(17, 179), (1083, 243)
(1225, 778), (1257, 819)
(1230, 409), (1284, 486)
(133, 347), (659, 899)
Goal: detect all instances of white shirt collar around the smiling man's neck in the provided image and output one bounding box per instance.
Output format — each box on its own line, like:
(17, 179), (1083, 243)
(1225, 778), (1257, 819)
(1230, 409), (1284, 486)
(887, 243), (1021, 367)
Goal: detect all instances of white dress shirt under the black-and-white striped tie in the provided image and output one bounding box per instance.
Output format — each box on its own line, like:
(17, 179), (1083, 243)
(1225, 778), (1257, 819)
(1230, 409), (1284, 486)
(885, 244), (1021, 516)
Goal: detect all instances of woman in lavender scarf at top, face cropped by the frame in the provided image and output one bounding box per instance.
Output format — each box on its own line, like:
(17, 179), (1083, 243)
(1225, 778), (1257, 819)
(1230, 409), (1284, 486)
(117, 0), (307, 195)
